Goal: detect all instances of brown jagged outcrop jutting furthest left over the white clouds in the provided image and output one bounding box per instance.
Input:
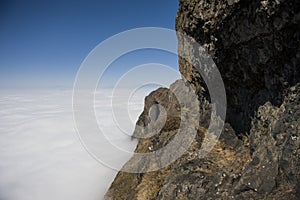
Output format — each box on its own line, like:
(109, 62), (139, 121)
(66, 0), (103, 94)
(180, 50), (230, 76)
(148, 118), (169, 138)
(106, 80), (204, 199)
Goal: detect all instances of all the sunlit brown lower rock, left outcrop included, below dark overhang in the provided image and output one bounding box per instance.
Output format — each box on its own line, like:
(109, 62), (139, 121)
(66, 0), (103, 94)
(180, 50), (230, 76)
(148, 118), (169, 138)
(106, 84), (300, 200)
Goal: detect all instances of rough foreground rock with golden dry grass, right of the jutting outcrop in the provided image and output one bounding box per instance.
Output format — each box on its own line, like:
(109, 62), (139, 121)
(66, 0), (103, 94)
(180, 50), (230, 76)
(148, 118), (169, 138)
(157, 84), (300, 199)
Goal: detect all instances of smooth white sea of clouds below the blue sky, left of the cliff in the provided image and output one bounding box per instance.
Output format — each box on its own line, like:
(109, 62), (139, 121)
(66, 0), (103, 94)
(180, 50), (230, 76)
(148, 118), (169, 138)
(0, 88), (153, 200)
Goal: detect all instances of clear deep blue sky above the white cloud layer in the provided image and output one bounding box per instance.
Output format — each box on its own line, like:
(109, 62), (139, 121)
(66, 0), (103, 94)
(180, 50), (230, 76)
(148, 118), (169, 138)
(0, 0), (178, 88)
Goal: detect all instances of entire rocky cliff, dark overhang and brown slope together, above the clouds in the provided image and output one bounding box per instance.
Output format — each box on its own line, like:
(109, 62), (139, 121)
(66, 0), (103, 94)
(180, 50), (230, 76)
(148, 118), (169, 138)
(106, 0), (300, 199)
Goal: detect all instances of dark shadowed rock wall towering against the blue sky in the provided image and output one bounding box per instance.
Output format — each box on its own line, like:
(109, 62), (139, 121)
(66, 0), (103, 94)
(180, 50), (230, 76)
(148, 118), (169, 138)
(176, 0), (300, 132)
